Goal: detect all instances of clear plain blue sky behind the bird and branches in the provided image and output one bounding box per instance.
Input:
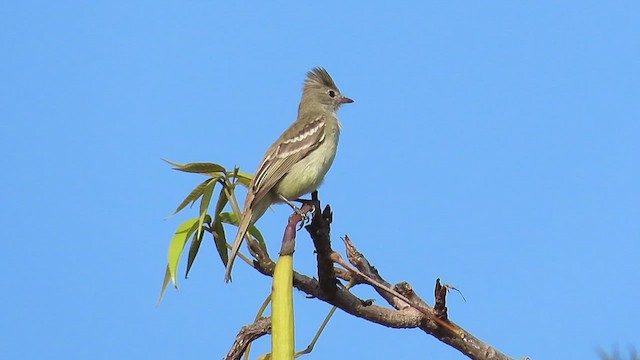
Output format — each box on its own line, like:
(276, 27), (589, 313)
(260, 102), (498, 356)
(0, 0), (640, 359)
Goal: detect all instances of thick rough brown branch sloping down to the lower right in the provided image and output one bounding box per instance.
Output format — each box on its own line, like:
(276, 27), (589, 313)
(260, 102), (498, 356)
(228, 194), (524, 360)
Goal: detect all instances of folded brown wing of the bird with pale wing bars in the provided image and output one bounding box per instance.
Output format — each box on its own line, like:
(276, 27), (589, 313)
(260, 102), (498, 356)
(251, 115), (326, 203)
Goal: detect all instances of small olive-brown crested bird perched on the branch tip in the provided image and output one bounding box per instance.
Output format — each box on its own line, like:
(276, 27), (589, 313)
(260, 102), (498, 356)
(225, 67), (353, 282)
